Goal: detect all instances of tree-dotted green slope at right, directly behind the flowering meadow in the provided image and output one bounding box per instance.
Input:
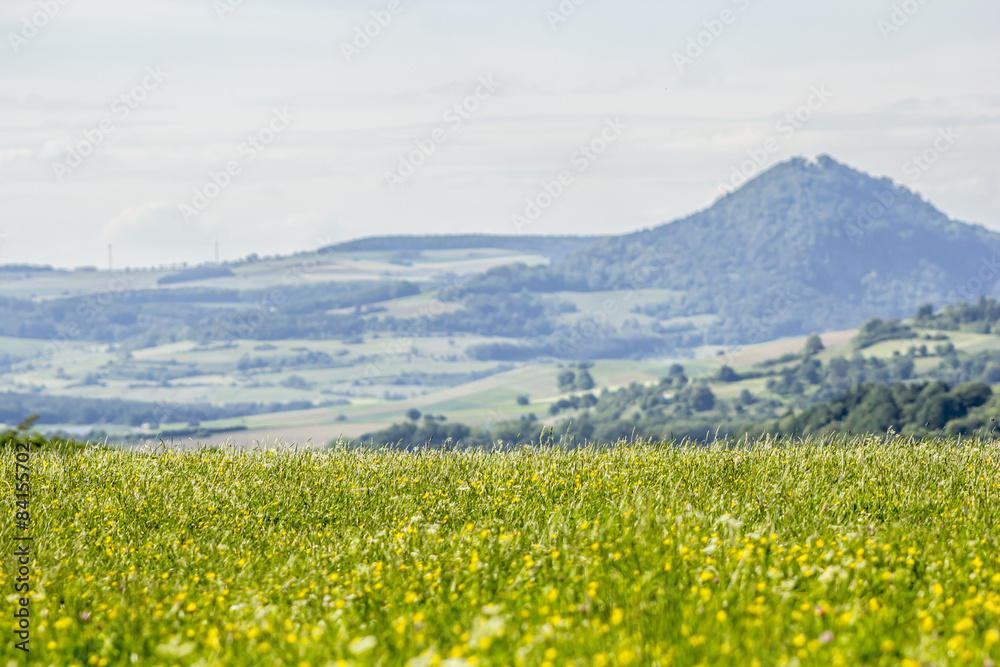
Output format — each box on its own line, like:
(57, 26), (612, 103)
(361, 298), (1000, 447)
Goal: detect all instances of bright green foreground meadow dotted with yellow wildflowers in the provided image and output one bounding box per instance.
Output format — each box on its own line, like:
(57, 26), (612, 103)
(0, 436), (1000, 667)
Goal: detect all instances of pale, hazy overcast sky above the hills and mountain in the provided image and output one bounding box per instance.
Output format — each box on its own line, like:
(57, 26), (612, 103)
(0, 0), (1000, 268)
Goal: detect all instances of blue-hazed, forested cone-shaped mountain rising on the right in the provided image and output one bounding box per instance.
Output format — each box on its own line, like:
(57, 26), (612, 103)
(471, 155), (1000, 343)
